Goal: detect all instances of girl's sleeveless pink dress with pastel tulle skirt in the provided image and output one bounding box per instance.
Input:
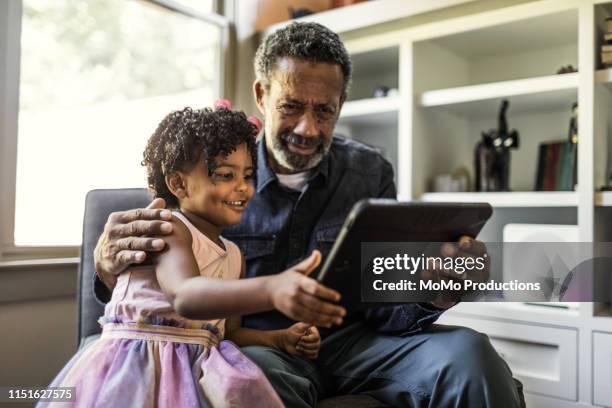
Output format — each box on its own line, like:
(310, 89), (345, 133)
(39, 212), (283, 408)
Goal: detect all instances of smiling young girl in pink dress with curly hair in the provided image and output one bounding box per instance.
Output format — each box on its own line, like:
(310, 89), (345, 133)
(40, 101), (343, 407)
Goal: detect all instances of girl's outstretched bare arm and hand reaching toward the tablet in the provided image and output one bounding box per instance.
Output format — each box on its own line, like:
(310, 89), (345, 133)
(154, 217), (346, 327)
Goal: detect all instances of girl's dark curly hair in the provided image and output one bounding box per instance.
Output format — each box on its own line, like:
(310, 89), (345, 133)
(142, 108), (258, 207)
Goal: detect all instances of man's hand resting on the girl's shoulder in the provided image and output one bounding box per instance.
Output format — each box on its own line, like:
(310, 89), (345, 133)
(94, 198), (172, 289)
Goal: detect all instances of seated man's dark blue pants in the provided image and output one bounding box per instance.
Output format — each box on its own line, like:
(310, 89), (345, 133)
(242, 323), (521, 408)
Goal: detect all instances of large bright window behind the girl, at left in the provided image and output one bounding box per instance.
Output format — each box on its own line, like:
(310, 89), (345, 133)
(0, 0), (227, 252)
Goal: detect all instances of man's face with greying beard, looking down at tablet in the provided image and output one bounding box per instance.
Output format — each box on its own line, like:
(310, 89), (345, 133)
(255, 58), (343, 174)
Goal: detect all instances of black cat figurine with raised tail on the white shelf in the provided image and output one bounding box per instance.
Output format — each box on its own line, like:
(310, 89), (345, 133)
(474, 99), (519, 191)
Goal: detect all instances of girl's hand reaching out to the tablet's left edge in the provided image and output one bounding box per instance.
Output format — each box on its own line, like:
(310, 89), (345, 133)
(268, 251), (346, 327)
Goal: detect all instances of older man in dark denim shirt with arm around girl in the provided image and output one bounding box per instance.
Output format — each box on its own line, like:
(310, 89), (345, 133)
(96, 23), (519, 407)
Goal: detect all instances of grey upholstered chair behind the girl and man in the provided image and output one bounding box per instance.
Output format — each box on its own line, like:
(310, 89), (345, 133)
(77, 188), (386, 408)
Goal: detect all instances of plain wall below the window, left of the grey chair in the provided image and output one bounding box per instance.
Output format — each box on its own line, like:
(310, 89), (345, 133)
(0, 265), (77, 386)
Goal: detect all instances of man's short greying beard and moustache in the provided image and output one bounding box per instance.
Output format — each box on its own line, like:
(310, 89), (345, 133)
(265, 128), (331, 172)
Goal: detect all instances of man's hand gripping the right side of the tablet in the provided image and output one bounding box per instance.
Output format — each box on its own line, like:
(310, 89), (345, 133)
(422, 235), (490, 309)
